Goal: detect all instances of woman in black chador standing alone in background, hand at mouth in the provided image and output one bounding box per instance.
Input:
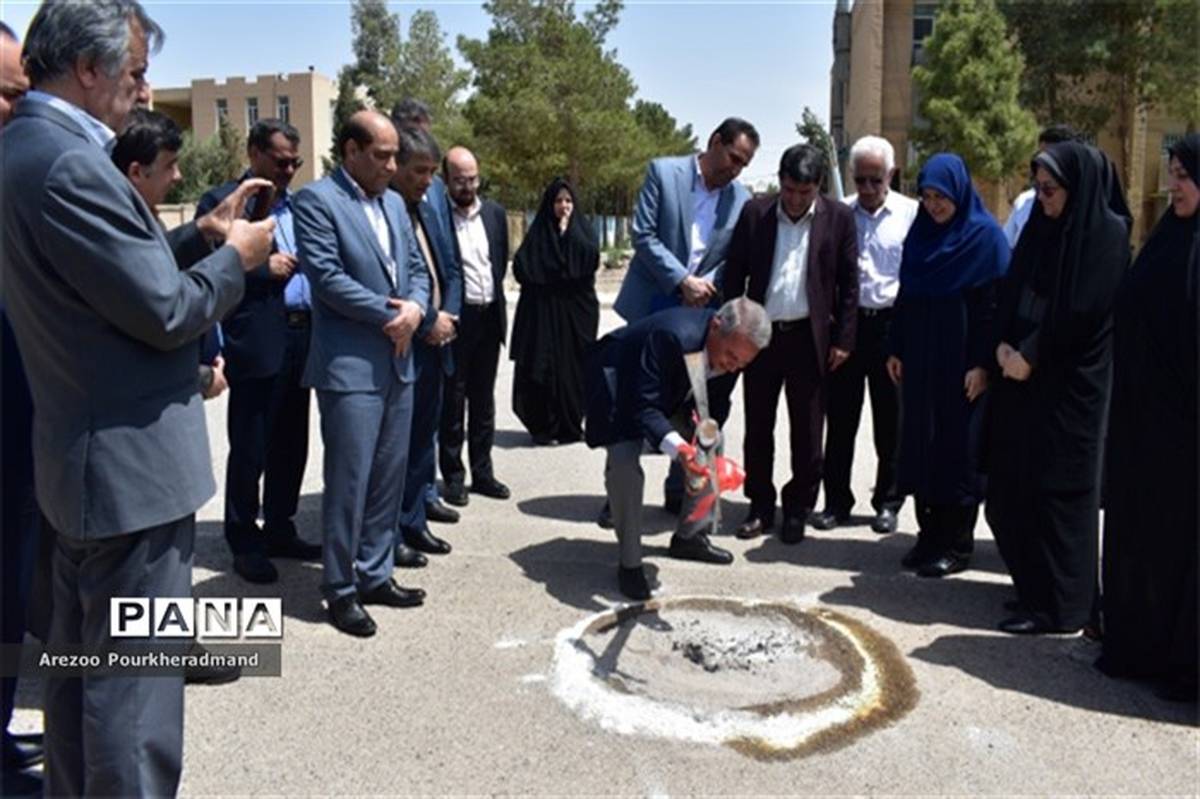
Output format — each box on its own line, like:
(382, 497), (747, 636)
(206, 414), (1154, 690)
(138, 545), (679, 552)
(509, 178), (600, 444)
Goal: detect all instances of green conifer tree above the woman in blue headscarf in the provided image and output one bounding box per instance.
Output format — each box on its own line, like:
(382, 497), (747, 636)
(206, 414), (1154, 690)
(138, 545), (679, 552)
(912, 0), (1037, 181)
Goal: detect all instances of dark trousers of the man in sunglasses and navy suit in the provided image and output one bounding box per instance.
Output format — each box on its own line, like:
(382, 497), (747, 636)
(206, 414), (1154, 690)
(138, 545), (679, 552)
(224, 325), (310, 554)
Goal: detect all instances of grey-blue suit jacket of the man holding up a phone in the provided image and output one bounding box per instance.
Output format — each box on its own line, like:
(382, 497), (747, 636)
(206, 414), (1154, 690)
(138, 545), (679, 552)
(0, 100), (245, 540)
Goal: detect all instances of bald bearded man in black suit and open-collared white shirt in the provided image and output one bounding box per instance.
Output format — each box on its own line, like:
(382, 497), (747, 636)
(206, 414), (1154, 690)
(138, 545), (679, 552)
(438, 148), (510, 506)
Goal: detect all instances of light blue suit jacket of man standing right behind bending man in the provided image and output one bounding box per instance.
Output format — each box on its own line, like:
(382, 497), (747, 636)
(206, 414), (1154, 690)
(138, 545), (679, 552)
(613, 156), (750, 322)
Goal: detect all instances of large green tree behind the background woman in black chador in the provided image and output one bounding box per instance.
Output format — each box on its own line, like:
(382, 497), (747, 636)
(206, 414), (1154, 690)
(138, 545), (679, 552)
(458, 0), (644, 210)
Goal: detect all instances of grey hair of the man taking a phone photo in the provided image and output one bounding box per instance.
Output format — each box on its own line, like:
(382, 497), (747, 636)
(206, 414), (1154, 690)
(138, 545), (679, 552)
(24, 0), (166, 88)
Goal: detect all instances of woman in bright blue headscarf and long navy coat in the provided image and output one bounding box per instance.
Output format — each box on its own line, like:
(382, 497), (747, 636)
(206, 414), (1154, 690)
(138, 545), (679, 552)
(888, 152), (1009, 577)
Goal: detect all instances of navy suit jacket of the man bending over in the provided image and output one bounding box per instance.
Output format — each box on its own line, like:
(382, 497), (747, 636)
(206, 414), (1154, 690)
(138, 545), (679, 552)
(583, 307), (732, 449)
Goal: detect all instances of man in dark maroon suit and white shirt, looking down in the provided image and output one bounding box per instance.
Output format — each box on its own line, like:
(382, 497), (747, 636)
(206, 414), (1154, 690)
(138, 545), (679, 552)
(725, 144), (858, 543)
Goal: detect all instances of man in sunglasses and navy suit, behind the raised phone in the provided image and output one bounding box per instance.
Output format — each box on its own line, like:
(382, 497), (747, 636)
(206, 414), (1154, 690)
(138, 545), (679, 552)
(196, 119), (320, 583)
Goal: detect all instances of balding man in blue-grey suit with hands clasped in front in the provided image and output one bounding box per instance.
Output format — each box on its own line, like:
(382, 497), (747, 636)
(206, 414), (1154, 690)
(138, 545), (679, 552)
(294, 110), (430, 637)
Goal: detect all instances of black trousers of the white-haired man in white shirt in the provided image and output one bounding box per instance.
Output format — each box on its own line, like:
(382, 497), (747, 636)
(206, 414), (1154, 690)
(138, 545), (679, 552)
(824, 308), (904, 516)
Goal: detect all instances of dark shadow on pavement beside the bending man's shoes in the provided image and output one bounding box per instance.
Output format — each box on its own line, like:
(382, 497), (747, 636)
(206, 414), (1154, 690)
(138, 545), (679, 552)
(509, 537), (667, 611)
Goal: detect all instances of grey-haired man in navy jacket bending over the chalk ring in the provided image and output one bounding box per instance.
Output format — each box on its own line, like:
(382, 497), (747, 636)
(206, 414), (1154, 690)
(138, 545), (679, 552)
(583, 298), (770, 601)
